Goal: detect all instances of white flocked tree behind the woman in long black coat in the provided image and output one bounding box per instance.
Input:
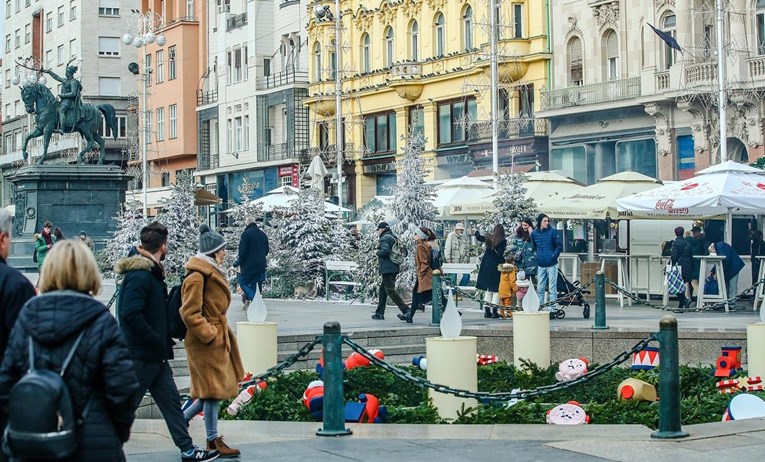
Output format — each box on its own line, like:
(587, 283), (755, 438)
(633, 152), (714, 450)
(481, 171), (539, 231)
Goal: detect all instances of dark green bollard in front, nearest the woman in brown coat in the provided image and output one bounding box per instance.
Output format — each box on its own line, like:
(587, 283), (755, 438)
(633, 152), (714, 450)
(316, 321), (353, 436)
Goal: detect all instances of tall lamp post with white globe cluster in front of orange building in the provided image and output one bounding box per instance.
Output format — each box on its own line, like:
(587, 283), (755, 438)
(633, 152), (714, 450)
(122, 9), (167, 219)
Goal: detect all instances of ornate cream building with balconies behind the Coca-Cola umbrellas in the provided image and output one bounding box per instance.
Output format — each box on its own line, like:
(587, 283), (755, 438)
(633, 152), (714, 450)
(539, 0), (765, 183)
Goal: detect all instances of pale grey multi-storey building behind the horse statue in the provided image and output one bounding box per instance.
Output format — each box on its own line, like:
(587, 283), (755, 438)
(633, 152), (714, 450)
(0, 0), (140, 207)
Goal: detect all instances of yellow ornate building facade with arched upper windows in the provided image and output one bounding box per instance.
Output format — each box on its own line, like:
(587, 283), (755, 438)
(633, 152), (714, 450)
(306, 0), (551, 206)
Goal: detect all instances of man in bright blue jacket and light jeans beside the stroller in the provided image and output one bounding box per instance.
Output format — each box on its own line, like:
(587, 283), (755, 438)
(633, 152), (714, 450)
(531, 213), (563, 312)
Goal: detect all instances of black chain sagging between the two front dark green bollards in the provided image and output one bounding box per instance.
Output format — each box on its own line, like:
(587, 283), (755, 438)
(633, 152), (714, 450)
(343, 333), (656, 402)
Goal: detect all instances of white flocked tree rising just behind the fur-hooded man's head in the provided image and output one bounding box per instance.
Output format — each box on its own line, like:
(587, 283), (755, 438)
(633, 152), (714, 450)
(157, 172), (200, 285)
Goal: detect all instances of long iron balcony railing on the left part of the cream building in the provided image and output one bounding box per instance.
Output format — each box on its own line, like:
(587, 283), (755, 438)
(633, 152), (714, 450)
(542, 77), (640, 111)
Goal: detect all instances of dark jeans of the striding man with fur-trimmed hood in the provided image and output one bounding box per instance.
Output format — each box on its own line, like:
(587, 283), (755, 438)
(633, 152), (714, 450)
(133, 359), (194, 452)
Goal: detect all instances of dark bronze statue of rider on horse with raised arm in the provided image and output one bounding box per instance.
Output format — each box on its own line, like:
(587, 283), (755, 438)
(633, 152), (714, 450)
(17, 61), (117, 164)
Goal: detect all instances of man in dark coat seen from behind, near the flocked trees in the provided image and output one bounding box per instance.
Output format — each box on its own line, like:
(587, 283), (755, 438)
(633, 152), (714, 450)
(234, 217), (268, 310)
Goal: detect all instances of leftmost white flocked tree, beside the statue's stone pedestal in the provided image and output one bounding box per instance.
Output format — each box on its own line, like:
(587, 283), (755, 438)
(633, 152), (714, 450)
(98, 201), (146, 278)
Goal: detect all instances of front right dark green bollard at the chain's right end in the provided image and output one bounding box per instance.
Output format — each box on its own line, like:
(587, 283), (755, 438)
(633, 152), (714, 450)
(651, 315), (688, 439)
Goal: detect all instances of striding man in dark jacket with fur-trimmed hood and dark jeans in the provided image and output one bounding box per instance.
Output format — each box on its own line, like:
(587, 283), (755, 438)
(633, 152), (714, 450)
(114, 222), (220, 462)
